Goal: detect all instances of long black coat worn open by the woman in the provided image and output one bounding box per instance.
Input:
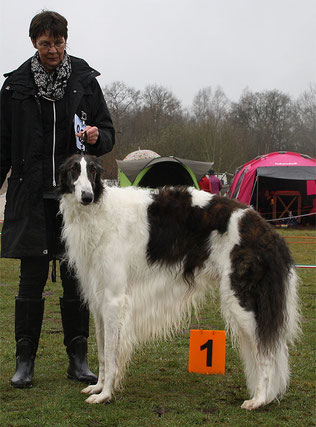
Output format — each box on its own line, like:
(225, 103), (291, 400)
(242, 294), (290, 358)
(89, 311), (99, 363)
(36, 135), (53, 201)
(0, 57), (114, 258)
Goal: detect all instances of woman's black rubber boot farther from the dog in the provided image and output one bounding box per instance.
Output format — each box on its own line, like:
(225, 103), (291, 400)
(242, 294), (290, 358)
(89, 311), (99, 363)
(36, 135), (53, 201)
(11, 297), (44, 388)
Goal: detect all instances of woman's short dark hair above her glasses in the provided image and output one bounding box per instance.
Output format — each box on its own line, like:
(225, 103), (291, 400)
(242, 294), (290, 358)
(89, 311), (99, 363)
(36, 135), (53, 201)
(29, 10), (68, 40)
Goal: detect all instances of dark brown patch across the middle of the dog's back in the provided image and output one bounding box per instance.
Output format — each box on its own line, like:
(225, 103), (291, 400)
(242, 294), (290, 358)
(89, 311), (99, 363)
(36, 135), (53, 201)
(147, 188), (246, 285)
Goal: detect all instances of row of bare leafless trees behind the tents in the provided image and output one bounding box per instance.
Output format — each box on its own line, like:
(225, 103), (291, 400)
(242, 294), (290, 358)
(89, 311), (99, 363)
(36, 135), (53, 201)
(103, 81), (316, 178)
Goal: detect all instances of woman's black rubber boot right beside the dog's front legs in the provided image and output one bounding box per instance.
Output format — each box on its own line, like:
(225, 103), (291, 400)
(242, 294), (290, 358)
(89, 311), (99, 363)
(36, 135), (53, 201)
(60, 297), (98, 384)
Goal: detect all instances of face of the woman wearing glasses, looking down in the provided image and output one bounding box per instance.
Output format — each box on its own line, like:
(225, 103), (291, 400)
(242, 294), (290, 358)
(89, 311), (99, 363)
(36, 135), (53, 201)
(32, 31), (66, 73)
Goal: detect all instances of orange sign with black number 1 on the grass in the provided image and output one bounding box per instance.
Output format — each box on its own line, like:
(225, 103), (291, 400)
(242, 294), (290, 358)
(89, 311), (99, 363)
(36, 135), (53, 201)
(189, 329), (226, 374)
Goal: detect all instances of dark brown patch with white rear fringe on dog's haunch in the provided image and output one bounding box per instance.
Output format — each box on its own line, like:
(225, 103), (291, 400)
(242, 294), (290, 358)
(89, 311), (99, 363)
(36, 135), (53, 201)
(230, 210), (300, 352)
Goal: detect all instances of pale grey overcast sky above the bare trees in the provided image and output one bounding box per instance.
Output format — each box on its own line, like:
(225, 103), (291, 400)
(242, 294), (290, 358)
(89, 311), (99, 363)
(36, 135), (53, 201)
(0, 0), (316, 107)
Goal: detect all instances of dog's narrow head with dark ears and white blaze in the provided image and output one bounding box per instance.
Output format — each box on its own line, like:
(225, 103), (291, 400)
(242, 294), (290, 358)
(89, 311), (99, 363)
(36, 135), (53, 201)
(58, 154), (104, 205)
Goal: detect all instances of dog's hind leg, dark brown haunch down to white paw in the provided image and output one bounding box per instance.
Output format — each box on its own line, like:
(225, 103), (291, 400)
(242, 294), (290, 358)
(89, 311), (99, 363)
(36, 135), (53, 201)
(231, 211), (301, 409)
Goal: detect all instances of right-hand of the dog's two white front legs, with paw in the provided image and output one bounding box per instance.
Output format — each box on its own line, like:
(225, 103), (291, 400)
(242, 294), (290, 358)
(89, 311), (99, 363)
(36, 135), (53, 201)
(86, 298), (121, 403)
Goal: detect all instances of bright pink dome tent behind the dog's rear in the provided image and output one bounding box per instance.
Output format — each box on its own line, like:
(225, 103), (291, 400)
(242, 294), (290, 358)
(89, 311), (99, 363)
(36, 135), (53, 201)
(228, 151), (316, 221)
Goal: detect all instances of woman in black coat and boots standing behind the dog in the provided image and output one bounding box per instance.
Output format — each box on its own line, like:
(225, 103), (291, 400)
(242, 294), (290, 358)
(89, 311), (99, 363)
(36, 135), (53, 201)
(0, 11), (114, 388)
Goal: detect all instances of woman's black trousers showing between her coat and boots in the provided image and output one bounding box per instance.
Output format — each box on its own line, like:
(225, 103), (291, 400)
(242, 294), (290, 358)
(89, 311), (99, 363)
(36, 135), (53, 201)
(18, 199), (79, 299)
